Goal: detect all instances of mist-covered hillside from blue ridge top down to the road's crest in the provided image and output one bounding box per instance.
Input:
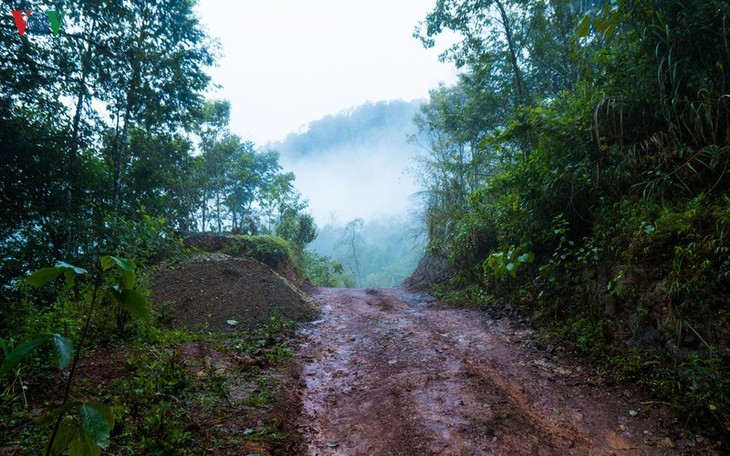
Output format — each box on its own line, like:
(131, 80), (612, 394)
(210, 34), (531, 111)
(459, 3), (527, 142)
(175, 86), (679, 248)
(271, 100), (423, 287)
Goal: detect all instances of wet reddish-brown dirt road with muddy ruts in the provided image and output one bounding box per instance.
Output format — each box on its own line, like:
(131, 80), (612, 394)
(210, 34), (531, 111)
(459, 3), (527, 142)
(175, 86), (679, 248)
(301, 288), (677, 456)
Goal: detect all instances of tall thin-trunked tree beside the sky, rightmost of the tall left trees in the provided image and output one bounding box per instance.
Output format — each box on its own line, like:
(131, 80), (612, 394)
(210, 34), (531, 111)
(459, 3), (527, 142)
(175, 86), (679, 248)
(101, 0), (212, 210)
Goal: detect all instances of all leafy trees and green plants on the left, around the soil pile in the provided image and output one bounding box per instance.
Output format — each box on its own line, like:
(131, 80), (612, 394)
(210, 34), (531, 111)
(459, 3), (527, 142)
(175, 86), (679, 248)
(0, 0), (316, 454)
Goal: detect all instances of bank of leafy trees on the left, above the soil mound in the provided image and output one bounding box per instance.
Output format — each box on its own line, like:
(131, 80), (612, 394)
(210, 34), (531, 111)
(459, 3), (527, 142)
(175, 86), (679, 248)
(0, 0), (314, 291)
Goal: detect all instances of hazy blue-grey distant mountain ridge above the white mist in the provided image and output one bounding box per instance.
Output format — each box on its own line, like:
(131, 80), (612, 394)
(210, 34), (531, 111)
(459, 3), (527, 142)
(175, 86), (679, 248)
(268, 100), (425, 160)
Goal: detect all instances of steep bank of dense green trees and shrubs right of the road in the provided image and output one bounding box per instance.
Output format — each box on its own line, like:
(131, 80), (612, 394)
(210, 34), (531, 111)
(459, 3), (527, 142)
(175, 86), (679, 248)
(416, 0), (730, 433)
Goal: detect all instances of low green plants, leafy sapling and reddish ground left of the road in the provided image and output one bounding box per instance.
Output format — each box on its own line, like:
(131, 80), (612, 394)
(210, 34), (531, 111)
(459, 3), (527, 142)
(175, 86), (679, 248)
(0, 258), (298, 455)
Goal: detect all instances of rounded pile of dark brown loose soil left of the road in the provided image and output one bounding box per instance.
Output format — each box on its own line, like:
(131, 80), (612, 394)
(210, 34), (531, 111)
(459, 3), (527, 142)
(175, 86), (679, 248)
(150, 254), (317, 331)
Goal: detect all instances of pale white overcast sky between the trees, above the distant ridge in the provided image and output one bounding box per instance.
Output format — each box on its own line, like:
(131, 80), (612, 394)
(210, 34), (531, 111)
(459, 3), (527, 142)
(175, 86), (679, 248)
(193, 0), (456, 145)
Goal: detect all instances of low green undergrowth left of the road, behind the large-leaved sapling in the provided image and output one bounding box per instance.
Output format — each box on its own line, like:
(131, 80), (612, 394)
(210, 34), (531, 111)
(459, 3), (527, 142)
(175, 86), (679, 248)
(0, 268), (296, 455)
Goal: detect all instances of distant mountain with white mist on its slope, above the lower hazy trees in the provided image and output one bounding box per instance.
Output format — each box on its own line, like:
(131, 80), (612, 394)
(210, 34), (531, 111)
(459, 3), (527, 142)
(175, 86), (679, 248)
(267, 100), (422, 226)
